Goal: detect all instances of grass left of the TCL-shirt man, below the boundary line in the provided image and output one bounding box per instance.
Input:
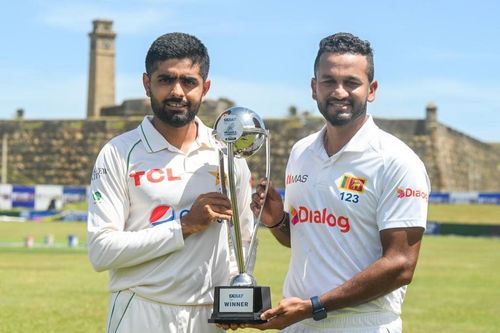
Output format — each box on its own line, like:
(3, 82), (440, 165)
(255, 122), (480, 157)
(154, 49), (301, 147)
(0, 248), (107, 333)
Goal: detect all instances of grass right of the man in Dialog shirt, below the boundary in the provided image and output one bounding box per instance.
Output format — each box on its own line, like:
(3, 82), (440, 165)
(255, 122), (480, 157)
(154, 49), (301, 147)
(403, 236), (500, 333)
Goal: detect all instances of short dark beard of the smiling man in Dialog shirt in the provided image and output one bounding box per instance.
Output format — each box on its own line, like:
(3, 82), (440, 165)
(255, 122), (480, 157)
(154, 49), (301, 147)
(317, 98), (367, 126)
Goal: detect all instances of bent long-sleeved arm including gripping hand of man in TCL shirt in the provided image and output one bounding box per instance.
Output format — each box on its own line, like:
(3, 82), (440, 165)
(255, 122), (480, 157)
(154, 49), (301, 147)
(87, 144), (232, 271)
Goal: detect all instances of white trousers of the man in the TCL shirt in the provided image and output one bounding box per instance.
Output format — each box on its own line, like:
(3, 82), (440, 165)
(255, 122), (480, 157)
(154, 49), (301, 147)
(106, 290), (224, 333)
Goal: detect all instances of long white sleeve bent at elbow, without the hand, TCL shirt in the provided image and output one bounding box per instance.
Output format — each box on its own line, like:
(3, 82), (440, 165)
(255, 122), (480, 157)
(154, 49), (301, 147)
(87, 143), (184, 271)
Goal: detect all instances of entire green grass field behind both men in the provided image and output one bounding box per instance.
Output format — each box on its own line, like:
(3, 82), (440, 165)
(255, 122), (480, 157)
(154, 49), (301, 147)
(0, 202), (500, 333)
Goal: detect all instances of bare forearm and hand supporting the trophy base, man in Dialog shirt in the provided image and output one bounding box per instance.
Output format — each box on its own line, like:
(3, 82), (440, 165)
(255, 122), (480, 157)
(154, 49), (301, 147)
(248, 227), (424, 329)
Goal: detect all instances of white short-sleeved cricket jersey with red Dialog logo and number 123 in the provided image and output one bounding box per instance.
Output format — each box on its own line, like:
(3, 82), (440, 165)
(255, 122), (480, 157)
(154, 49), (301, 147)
(284, 116), (430, 315)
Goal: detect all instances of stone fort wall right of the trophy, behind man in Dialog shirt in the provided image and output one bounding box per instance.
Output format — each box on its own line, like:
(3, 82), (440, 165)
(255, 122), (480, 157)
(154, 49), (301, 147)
(248, 114), (500, 192)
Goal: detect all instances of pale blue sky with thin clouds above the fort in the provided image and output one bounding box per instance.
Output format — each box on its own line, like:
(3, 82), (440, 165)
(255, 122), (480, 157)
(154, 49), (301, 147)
(0, 0), (500, 142)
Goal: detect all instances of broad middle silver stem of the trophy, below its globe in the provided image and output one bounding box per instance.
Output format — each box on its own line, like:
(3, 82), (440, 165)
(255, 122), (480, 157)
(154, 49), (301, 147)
(227, 142), (245, 274)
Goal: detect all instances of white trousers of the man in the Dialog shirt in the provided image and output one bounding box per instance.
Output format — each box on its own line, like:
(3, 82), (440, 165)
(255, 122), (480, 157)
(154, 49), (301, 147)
(280, 313), (403, 333)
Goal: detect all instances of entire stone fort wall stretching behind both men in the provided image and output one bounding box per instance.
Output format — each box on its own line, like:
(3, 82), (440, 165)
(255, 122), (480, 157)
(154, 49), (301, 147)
(0, 108), (500, 192)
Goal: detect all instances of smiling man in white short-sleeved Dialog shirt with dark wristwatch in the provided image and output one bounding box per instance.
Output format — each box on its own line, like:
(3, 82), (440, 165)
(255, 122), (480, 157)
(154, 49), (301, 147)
(246, 33), (430, 333)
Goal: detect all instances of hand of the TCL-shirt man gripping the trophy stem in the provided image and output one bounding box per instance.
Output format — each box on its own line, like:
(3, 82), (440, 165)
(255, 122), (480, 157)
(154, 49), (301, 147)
(181, 192), (233, 238)
